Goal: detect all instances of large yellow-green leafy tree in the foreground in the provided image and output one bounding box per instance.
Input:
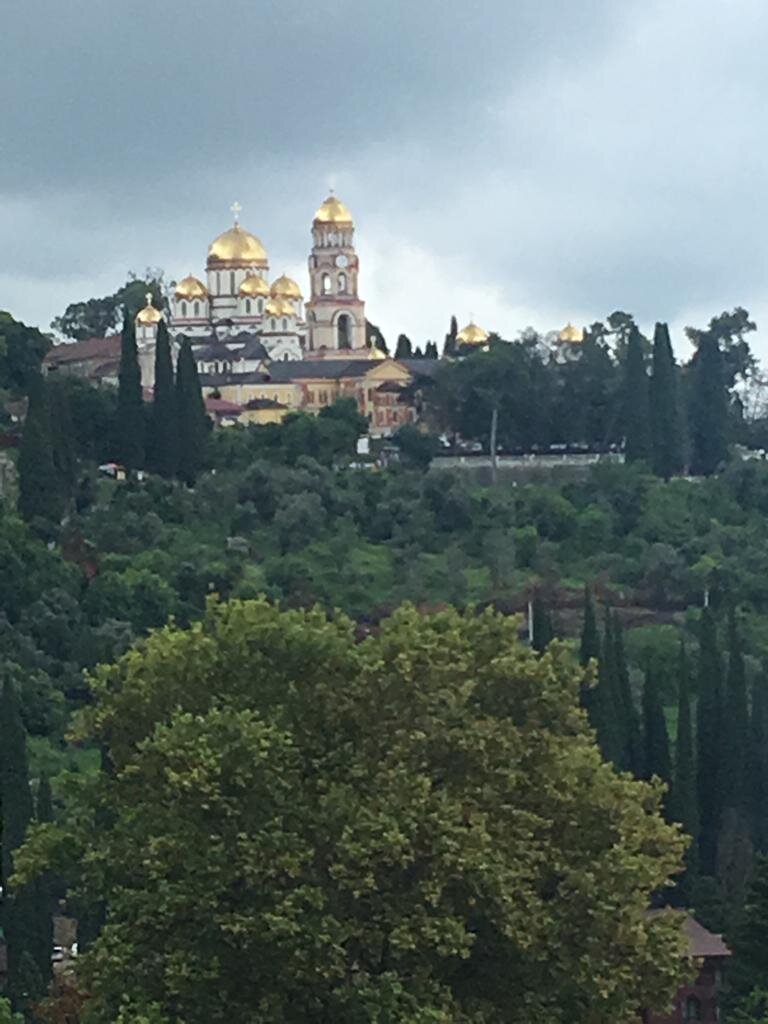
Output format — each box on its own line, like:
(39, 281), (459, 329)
(20, 601), (682, 1024)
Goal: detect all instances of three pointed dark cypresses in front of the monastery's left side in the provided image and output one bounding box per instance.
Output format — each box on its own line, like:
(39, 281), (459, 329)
(115, 315), (208, 484)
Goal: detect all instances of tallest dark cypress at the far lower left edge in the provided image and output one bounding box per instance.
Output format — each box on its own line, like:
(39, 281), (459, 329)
(0, 680), (43, 1006)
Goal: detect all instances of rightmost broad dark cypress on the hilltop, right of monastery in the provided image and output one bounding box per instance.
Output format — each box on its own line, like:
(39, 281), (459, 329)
(689, 333), (728, 476)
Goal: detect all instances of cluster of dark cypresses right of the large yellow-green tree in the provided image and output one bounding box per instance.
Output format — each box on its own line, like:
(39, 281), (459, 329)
(581, 591), (768, 927)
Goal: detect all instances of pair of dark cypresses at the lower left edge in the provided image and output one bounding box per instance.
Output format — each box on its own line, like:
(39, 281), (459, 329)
(0, 680), (54, 1010)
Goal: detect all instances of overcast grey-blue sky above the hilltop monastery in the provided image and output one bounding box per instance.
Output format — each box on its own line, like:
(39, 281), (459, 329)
(0, 0), (768, 356)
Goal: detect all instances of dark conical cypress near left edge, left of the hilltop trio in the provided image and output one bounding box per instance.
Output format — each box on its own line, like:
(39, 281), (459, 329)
(18, 374), (63, 522)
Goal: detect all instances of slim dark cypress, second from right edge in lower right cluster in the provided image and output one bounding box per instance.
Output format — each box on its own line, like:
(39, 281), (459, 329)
(720, 608), (750, 812)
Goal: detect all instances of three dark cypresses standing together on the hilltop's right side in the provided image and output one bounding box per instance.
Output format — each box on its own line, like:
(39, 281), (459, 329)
(624, 324), (728, 480)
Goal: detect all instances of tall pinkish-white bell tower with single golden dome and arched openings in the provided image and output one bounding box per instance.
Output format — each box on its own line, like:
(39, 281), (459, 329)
(306, 193), (370, 358)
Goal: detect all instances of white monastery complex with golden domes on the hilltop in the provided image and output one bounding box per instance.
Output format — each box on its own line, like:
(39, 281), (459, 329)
(45, 194), (582, 435)
